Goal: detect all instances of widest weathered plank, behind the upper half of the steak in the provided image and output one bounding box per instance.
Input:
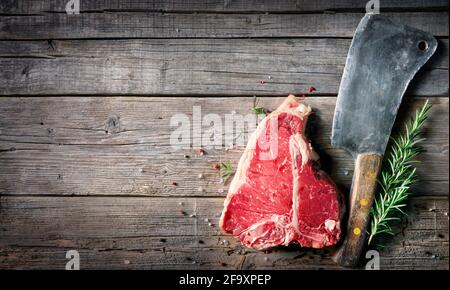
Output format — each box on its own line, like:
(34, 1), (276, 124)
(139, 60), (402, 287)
(0, 97), (449, 197)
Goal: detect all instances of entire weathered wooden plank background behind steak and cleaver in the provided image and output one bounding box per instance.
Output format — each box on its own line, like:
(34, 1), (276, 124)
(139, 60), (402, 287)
(0, 0), (449, 269)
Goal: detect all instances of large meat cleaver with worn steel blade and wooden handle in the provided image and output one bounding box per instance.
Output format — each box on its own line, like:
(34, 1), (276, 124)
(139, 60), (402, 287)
(331, 14), (437, 267)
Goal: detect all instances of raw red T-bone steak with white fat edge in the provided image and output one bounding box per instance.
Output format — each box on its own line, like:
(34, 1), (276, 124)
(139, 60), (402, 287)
(220, 95), (343, 250)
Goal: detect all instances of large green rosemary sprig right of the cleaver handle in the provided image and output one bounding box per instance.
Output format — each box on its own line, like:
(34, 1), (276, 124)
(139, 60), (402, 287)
(368, 100), (431, 244)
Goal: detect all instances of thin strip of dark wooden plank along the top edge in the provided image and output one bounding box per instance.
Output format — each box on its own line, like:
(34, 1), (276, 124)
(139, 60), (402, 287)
(0, 0), (448, 14)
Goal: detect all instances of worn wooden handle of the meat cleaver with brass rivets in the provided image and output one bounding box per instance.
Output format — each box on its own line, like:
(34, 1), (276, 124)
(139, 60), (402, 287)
(333, 153), (383, 267)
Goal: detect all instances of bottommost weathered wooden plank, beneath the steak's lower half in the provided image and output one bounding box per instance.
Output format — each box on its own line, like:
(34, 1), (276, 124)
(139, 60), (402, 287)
(0, 196), (449, 269)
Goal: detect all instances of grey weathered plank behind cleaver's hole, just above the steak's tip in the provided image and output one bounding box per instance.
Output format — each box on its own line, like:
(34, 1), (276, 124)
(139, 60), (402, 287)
(0, 39), (449, 96)
